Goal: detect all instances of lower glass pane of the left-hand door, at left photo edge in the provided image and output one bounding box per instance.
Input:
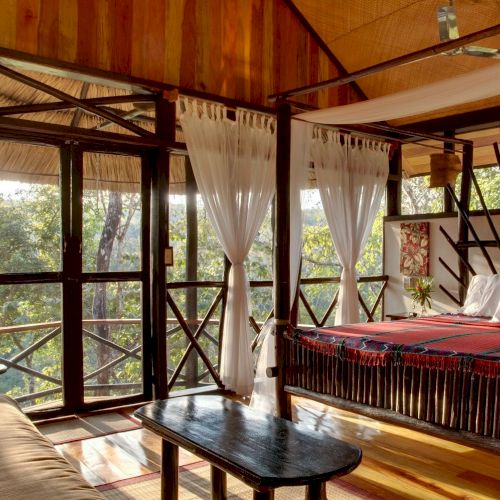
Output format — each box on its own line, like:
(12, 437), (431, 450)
(0, 283), (62, 407)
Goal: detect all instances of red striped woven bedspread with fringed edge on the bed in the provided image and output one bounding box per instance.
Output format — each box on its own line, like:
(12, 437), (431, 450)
(288, 314), (500, 377)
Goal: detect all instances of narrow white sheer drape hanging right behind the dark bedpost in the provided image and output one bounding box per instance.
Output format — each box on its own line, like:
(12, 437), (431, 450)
(250, 120), (313, 415)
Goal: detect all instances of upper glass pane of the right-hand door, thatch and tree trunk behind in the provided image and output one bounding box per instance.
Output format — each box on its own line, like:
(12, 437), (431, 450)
(82, 153), (141, 272)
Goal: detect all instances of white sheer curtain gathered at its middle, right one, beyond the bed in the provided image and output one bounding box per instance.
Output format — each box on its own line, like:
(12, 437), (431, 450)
(311, 127), (389, 325)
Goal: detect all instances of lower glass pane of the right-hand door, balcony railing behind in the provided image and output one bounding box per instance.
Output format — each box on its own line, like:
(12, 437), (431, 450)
(83, 282), (142, 401)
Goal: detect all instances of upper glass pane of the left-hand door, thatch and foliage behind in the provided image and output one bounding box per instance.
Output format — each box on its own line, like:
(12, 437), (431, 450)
(0, 141), (61, 273)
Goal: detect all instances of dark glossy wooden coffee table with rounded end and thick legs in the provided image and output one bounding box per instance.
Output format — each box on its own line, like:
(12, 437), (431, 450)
(135, 395), (361, 500)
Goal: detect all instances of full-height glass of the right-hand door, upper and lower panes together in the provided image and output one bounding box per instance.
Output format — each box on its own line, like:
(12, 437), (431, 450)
(81, 151), (149, 404)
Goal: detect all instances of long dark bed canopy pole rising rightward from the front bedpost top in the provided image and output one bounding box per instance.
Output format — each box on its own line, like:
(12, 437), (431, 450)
(268, 24), (500, 102)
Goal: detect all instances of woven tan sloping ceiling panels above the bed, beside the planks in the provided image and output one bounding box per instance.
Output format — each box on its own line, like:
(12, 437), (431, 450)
(293, 0), (500, 124)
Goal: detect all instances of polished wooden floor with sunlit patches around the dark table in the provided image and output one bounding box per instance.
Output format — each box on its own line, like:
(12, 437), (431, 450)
(51, 398), (500, 499)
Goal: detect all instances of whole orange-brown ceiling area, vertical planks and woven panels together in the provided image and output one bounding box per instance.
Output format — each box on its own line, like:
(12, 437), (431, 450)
(0, 0), (500, 129)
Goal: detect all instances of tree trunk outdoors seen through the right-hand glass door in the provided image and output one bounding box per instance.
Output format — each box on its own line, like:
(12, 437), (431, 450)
(92, 192), (122, 394)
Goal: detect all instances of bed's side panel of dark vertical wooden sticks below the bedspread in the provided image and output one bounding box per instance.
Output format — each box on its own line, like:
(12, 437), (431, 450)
(285, 339), (500, 439)
